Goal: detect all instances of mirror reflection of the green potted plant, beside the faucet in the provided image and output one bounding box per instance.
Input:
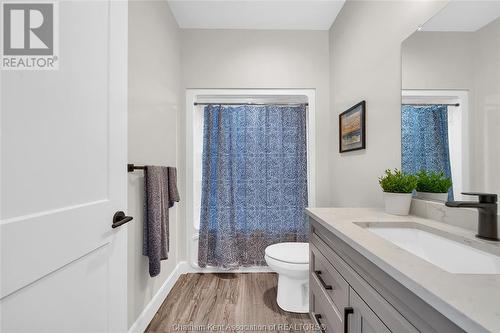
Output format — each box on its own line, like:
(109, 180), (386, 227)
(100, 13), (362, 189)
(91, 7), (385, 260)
(417, 170), (452, 201)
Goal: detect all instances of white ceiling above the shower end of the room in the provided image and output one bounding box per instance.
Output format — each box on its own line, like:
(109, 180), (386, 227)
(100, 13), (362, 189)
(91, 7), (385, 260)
(168, 0), (345, 30)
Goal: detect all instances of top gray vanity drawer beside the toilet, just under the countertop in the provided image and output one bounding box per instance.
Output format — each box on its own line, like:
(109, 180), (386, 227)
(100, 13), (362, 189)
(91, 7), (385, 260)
(309, 240), (349, 312)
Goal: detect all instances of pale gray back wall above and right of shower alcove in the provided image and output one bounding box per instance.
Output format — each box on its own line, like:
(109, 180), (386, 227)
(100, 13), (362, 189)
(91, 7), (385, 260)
(181, 30), (335, 206)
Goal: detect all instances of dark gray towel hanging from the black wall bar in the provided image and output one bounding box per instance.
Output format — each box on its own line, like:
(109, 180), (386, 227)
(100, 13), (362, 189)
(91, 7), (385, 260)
(142, 166), (179, 277)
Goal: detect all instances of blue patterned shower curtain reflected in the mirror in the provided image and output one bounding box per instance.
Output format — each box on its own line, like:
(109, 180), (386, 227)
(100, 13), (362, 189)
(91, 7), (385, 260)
(401, 104), (453, 200)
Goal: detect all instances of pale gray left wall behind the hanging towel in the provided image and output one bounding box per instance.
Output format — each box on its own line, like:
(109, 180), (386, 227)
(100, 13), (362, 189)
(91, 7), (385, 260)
(128, 1), (185, 326)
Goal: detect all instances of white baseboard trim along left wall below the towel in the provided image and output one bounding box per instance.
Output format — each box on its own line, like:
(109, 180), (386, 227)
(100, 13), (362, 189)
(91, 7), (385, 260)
(128, 261), (190, 333)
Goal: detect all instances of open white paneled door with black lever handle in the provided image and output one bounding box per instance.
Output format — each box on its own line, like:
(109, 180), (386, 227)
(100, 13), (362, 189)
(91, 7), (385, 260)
(0, 0), (129, 333)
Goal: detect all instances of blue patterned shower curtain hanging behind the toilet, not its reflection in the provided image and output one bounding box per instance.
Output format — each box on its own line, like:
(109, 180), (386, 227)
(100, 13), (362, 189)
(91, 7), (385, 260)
(198, 105), (308, 269)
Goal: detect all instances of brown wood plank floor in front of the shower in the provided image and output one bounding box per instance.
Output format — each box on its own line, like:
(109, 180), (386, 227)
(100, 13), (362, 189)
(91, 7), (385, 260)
(146, 273), (314, 333)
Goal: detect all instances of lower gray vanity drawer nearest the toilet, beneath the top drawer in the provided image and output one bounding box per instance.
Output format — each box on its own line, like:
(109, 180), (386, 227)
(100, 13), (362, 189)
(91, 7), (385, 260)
(309, 270), (343, 333)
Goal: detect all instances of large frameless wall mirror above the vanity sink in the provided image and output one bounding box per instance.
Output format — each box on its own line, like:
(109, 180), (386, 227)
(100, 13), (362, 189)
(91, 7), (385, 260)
(401, 1), (500, 200)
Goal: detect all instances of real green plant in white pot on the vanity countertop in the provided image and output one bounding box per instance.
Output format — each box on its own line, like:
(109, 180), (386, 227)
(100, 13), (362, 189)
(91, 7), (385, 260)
(379, 169), (417, 215)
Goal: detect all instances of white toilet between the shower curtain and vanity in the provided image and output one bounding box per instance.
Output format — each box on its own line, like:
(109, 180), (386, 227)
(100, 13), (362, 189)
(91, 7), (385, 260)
(265, 243), (309, 313)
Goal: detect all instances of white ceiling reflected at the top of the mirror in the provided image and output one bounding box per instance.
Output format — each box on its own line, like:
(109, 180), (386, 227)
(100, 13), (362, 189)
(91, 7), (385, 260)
(421, 0), (500, 31)
